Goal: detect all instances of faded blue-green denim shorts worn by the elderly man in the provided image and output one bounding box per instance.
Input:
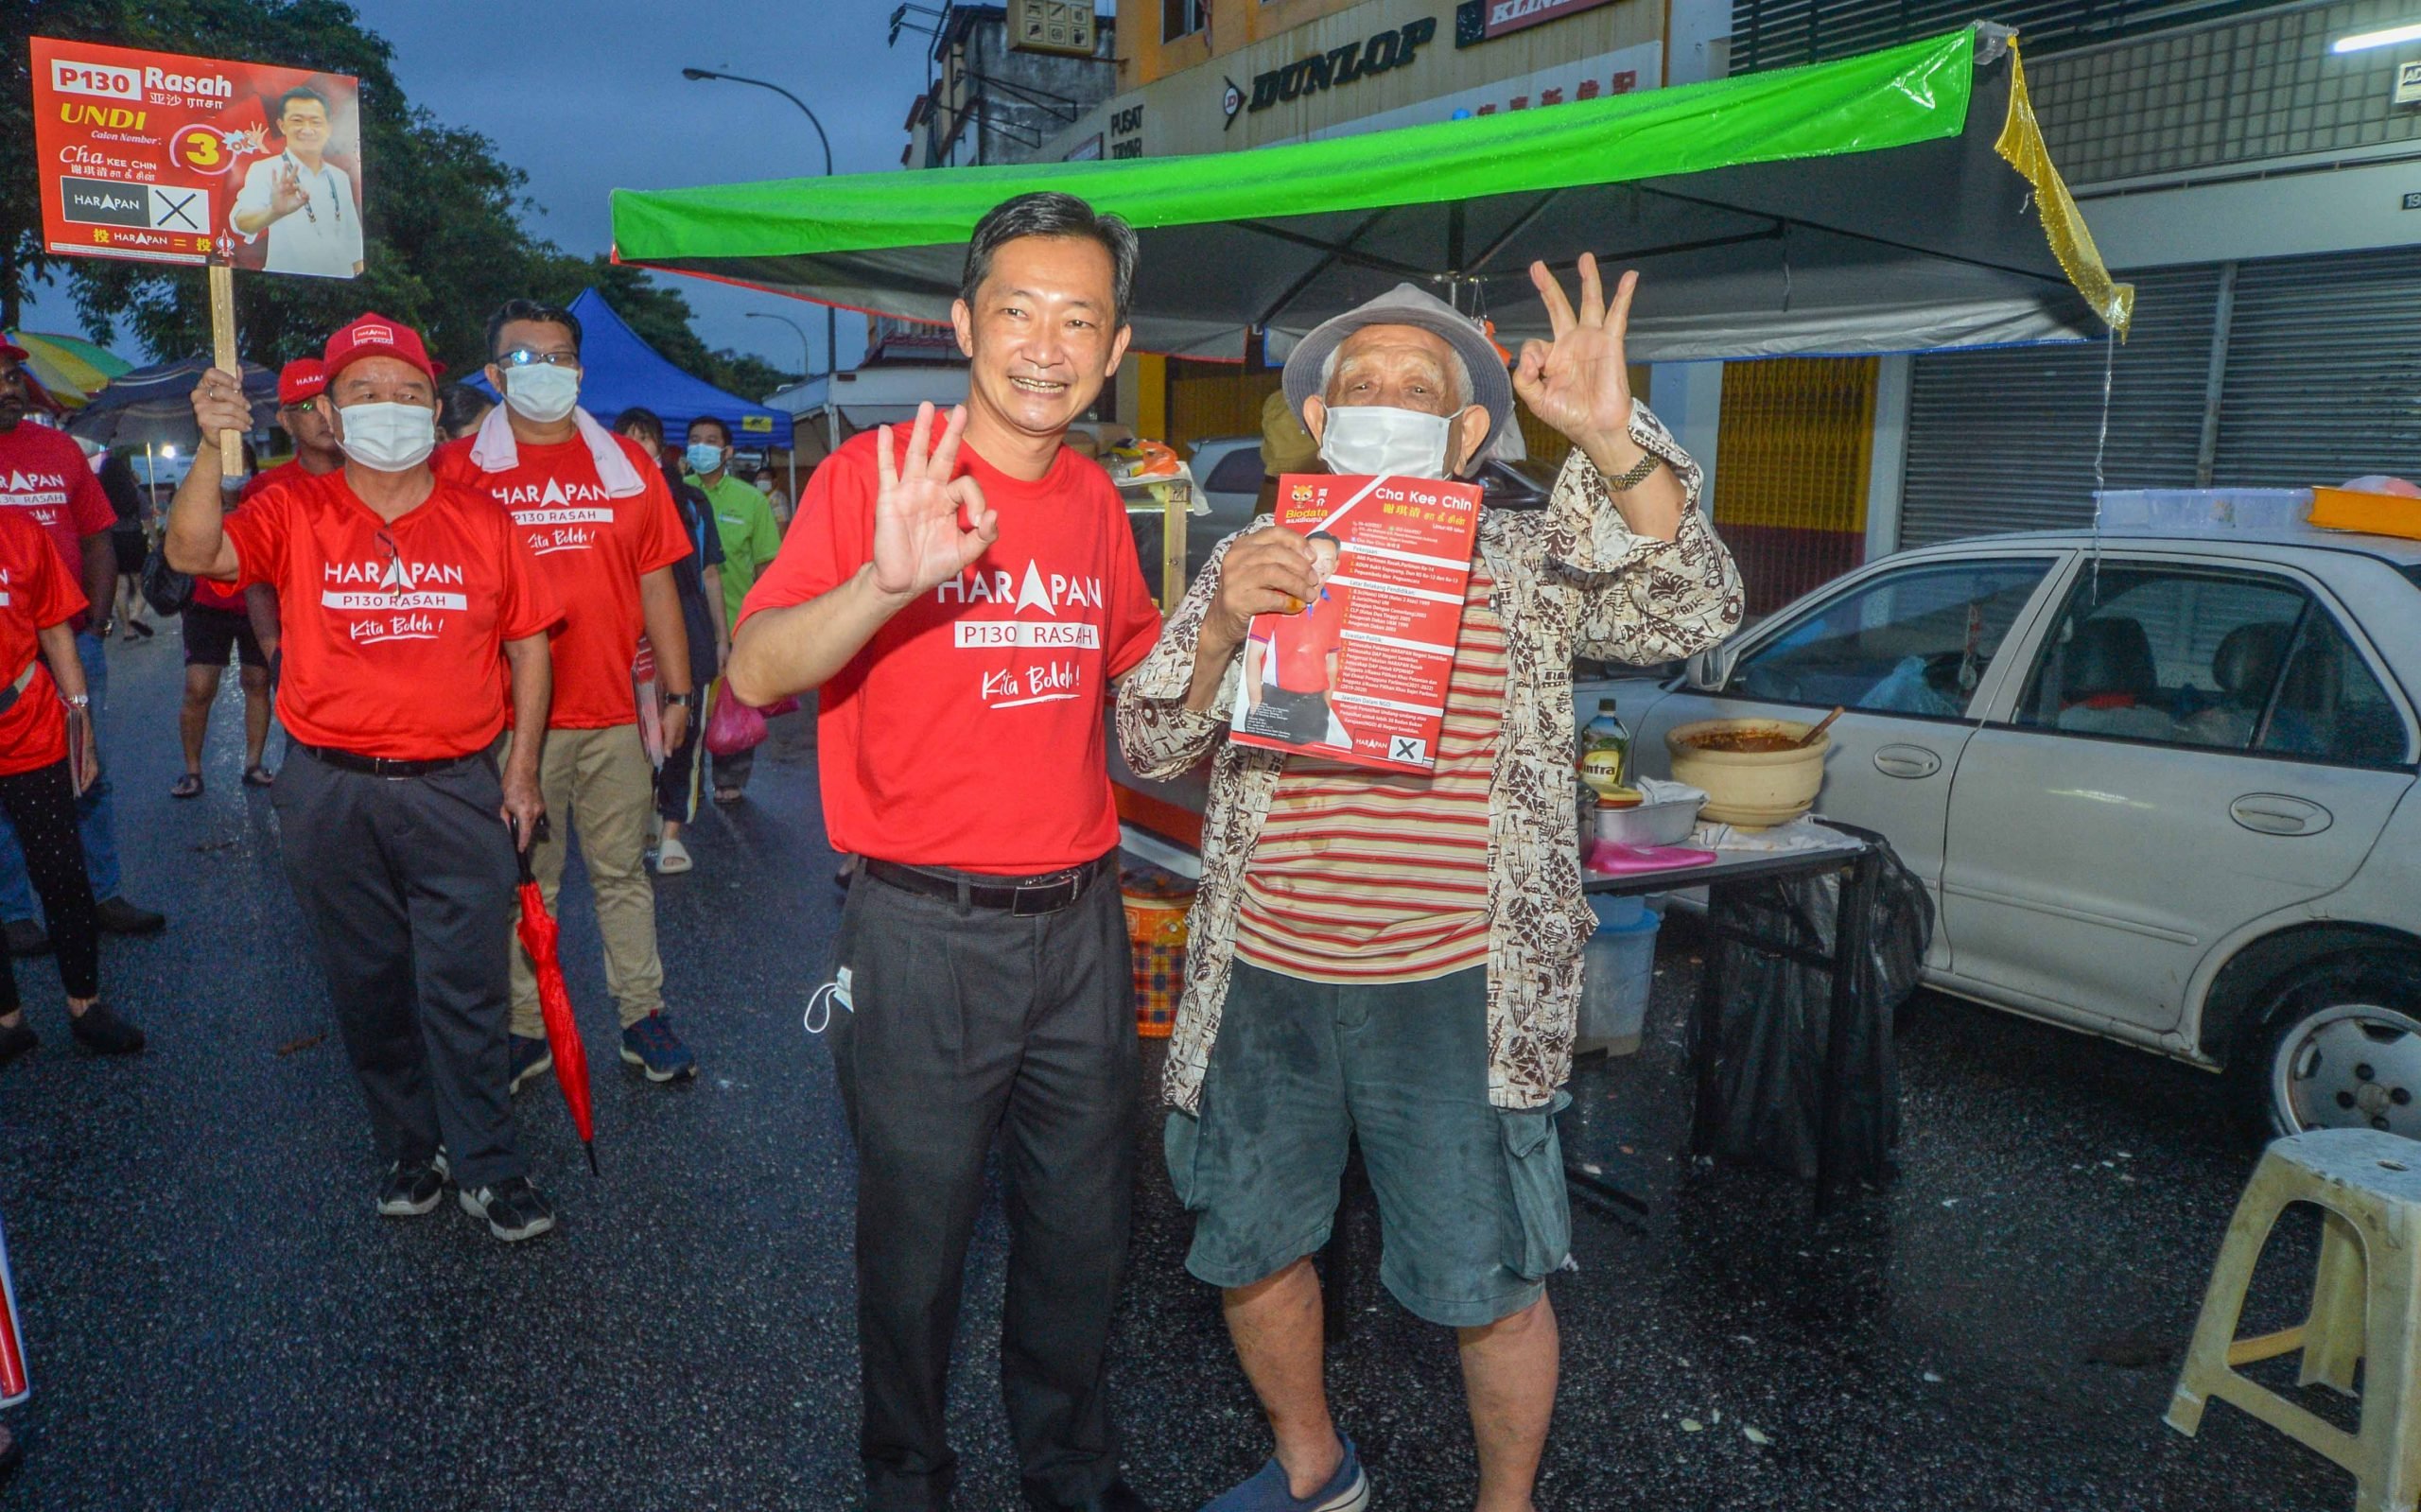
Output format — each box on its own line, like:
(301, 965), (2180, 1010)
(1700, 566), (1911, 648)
(1167, 963), (1571, 1329)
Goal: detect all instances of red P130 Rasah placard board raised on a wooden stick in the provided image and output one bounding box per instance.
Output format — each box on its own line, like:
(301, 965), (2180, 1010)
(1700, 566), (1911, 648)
(34, 36), (363, 278)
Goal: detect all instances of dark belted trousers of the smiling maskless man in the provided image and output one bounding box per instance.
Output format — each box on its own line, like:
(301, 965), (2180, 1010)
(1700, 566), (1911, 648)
(833, 868), (1141, 1512)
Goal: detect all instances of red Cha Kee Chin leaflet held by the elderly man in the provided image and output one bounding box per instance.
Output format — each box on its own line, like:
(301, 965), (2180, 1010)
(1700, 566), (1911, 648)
(1229, 472), (1479, 772)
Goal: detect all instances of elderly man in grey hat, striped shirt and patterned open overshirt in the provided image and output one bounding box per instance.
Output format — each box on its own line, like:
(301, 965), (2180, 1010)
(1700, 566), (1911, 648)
(1119, 256), (1741, 1512)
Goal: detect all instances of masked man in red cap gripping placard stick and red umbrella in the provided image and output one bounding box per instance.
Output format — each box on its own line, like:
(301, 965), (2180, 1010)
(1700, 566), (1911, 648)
(167, 315), (562, 1241)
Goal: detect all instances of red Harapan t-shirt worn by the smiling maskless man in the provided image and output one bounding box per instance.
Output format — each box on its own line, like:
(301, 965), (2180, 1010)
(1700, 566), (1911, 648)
(734, 433), (1159, 876)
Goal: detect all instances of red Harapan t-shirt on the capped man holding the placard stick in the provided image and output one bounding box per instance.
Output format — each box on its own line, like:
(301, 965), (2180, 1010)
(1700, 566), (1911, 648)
(228, 469), (562, 762)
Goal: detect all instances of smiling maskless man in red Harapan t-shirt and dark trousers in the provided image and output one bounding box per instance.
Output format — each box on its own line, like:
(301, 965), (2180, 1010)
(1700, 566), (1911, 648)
(729, 194), (1159, 1512)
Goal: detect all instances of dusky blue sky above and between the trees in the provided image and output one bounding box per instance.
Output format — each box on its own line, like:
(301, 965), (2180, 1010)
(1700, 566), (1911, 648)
(25, 0), (939, 370)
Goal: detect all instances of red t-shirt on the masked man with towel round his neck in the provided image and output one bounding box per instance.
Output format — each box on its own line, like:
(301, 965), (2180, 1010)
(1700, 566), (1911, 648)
(433, 436), (690, 731)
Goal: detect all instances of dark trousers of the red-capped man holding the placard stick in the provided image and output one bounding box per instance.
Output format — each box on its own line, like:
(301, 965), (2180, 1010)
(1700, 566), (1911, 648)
(269, 745), (528, 1190)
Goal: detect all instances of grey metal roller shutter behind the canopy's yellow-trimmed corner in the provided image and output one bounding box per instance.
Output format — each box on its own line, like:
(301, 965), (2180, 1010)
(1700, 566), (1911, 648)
(1901, 266), (2242, 547)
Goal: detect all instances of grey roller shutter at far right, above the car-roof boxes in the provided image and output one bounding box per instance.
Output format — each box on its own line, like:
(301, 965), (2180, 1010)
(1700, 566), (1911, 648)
(2213, 247), (2421, 486)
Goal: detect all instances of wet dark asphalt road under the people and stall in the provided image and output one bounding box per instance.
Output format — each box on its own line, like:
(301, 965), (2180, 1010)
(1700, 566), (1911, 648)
(0, 632), (2353, 1512)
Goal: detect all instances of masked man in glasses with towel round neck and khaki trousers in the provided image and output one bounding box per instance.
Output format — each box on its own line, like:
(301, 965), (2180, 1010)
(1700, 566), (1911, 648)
(436, 300), (697, 1091)
